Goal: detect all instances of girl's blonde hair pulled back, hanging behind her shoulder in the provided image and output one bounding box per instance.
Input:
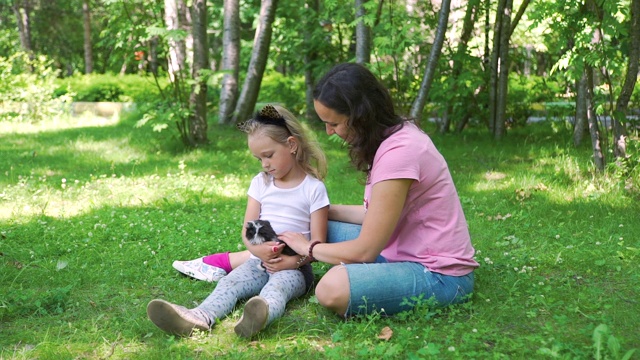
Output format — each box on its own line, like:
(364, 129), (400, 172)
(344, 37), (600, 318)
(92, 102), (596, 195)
(238, 105), (327, 180)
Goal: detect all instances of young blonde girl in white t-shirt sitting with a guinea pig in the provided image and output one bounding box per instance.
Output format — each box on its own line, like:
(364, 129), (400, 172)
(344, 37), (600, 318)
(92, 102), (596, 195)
(147, 105), (329, 337)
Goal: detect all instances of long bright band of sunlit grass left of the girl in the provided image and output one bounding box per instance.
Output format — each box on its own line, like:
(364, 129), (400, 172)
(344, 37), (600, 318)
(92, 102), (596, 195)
(0, 174), (250, 222)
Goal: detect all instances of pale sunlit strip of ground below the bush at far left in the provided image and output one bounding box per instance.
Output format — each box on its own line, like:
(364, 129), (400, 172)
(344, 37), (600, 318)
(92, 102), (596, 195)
(0, 113), (120, 134)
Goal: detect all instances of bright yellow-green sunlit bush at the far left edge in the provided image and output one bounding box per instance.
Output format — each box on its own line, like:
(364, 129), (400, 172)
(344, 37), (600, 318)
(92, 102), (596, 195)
(0, 53), (69, 122)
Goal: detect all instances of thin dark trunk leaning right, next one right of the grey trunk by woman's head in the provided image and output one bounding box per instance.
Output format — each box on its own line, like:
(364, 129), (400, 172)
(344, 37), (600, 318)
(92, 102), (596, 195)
(440, 0), (480, 134)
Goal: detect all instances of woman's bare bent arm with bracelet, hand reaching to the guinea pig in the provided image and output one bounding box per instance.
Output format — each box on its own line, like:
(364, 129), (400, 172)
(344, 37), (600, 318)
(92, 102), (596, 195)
(280, 179), (414, 264)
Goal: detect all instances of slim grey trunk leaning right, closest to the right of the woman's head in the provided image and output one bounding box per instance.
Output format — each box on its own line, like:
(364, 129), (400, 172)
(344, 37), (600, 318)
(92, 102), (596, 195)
(410, 0), (451, 121)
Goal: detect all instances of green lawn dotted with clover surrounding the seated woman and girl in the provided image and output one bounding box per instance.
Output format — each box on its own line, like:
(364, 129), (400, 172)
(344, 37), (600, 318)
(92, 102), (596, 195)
(0, 112), (640, 360)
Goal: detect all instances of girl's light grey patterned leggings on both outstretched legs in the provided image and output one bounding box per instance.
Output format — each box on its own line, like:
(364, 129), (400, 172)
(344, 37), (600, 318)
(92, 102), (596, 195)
(197, 259), (306, 325)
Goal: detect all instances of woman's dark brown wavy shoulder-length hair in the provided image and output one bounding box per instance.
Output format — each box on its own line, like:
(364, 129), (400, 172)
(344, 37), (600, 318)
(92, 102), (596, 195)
(313, 63), (404, 175)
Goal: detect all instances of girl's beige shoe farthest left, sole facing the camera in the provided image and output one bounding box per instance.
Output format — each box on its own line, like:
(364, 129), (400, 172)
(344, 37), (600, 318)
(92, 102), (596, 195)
(147, 299), (211, 337)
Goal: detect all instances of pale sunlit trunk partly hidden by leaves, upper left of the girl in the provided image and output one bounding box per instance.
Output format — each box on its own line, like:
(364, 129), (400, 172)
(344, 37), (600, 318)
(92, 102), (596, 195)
(164, 0), (187, 82)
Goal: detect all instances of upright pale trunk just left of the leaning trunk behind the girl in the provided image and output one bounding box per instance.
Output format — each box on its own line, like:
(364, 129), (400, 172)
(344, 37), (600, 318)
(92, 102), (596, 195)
(218, 0), (240, 124)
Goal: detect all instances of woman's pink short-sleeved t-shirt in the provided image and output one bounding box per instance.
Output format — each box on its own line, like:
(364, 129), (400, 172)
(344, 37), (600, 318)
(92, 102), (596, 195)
(364, 122), (479, 276)
